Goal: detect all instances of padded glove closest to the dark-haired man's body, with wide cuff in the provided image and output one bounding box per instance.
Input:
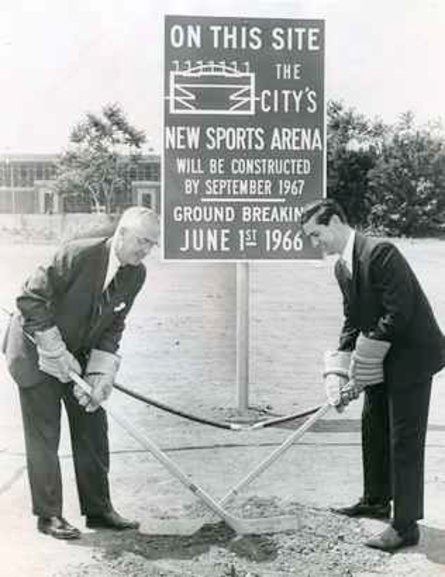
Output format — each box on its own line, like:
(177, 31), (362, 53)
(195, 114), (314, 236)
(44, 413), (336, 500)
(349, 333), (391, 389)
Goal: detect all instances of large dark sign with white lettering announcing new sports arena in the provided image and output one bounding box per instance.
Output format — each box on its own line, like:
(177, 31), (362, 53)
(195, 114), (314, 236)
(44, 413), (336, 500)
(162, 16), (326, 260)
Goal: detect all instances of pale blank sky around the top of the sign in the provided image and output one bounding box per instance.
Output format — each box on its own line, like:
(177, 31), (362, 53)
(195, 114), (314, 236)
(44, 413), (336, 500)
(0, 0), (445, 155)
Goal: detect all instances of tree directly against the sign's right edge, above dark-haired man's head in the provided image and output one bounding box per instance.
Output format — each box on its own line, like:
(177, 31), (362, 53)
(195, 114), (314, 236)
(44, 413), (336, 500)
(327, 101), (387, 225)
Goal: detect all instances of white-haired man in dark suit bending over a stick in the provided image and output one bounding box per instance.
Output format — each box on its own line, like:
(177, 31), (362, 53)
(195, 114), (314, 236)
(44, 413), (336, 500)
(4, 207), (159, 539)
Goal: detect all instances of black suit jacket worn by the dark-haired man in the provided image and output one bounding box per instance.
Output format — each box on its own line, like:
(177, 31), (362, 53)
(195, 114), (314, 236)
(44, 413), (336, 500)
(335, 233), (445, 388)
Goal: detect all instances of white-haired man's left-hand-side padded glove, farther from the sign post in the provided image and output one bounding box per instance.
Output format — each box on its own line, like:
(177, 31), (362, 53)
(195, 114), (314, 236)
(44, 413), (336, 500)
(34, 326), (82, 383)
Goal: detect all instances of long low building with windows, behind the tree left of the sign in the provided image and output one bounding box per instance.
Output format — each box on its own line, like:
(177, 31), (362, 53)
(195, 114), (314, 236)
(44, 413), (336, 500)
(0, 154), (161, 214)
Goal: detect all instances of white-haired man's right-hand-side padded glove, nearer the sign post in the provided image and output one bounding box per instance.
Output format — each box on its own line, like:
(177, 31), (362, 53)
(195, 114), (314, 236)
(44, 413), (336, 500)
(73, 349), (120, 413)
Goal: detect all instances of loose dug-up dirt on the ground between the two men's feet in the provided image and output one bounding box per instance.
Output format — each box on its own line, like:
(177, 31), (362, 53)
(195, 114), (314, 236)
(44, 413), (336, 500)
(52, 497), (391, 577)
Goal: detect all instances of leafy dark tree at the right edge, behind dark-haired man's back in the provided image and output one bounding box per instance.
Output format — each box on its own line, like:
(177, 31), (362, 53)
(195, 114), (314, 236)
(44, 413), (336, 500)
(368, 112), (445, 236)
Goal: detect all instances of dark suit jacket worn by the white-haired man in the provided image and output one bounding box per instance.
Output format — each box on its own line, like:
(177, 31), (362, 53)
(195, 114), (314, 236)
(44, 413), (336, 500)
(4, 238), (146, 387)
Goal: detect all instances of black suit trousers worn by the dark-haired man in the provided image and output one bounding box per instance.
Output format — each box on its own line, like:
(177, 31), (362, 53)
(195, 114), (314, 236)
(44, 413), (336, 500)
(362, 377), (432, 524)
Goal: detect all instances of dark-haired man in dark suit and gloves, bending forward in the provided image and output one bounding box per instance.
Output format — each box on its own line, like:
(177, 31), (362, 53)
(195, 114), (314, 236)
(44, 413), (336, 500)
(302, 200), (445, 551)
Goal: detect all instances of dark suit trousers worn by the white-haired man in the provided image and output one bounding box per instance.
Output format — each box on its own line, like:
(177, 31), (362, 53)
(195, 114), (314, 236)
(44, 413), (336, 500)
(19, 376), (111, 517)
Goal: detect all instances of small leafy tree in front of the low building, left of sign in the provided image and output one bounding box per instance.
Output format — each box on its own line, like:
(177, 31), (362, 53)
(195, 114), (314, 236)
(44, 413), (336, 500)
(55, 104), (145, 214)
